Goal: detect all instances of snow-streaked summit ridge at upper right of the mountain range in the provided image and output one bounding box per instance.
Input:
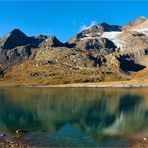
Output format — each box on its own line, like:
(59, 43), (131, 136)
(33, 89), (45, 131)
(69, 17), (148, 51)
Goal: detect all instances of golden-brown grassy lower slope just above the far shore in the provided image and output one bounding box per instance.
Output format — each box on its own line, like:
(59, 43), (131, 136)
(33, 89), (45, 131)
(0, 60), (127, 86)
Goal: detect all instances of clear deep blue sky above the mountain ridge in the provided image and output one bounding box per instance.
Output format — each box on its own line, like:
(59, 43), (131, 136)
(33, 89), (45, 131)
(0, 1), (148, 42)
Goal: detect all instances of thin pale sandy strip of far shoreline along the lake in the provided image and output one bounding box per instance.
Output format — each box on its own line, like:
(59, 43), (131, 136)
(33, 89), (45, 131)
(0, 80), (148, 88)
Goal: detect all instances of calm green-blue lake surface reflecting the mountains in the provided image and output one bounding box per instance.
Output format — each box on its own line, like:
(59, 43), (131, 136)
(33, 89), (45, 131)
(0, 88), (148, 147)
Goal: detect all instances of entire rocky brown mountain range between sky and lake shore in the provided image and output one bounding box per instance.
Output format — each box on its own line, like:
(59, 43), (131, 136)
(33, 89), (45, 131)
(0, 17), (148, 85)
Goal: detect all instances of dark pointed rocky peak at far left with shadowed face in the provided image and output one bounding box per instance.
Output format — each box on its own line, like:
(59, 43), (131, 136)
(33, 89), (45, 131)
(0, 29), (47, 68)
